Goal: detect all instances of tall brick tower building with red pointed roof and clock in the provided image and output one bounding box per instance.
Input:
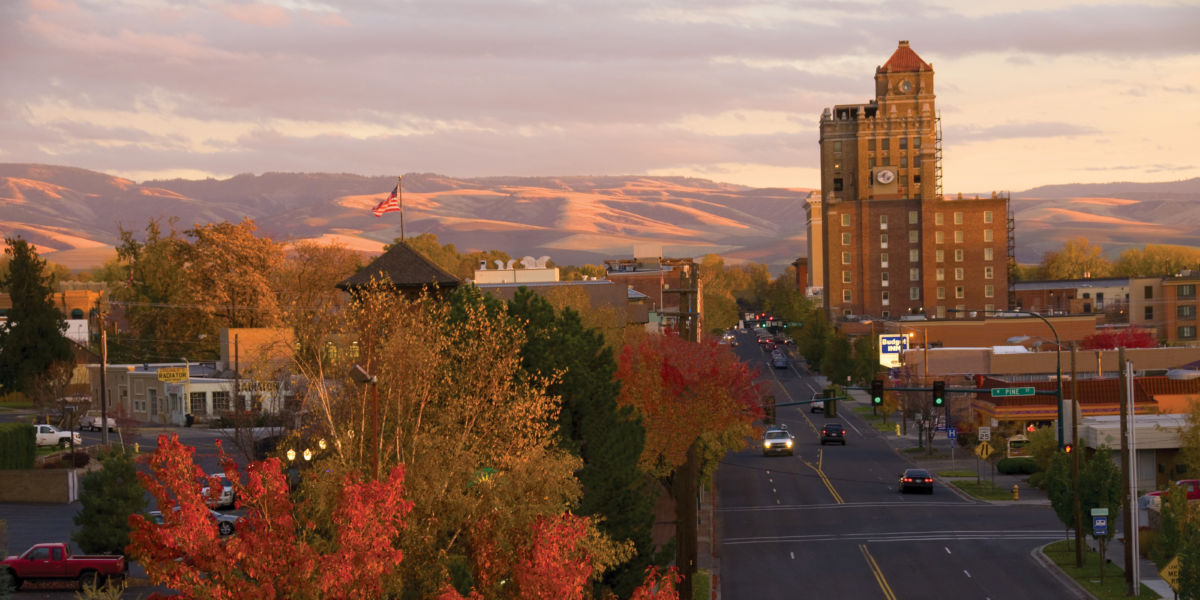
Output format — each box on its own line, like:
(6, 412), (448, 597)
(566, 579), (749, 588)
(806, 41), (1014, 318)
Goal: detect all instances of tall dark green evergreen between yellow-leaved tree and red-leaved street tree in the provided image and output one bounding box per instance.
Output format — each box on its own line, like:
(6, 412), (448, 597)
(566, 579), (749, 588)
(509, 288), (655, 598)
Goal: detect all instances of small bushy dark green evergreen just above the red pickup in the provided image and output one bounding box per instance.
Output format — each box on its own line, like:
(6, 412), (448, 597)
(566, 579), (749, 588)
(71, 449), (146, 554)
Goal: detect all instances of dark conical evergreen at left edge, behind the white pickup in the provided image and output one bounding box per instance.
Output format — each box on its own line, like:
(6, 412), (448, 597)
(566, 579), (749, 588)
(0, 238), (73, 395)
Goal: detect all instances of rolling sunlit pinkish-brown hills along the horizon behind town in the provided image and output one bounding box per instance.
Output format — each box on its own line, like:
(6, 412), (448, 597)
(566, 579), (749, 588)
(0, 163), (1200, 272)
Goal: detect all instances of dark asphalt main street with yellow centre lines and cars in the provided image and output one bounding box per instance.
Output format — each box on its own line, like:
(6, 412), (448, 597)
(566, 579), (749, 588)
(716, 334), (1074, 600)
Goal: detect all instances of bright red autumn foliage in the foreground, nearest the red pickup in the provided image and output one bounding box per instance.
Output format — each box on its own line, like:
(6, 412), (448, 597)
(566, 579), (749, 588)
(126, 436), (412, 599)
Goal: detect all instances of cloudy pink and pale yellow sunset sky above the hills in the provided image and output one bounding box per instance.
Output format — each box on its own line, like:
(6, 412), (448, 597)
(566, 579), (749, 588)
(0, 0), (1200, 193)
